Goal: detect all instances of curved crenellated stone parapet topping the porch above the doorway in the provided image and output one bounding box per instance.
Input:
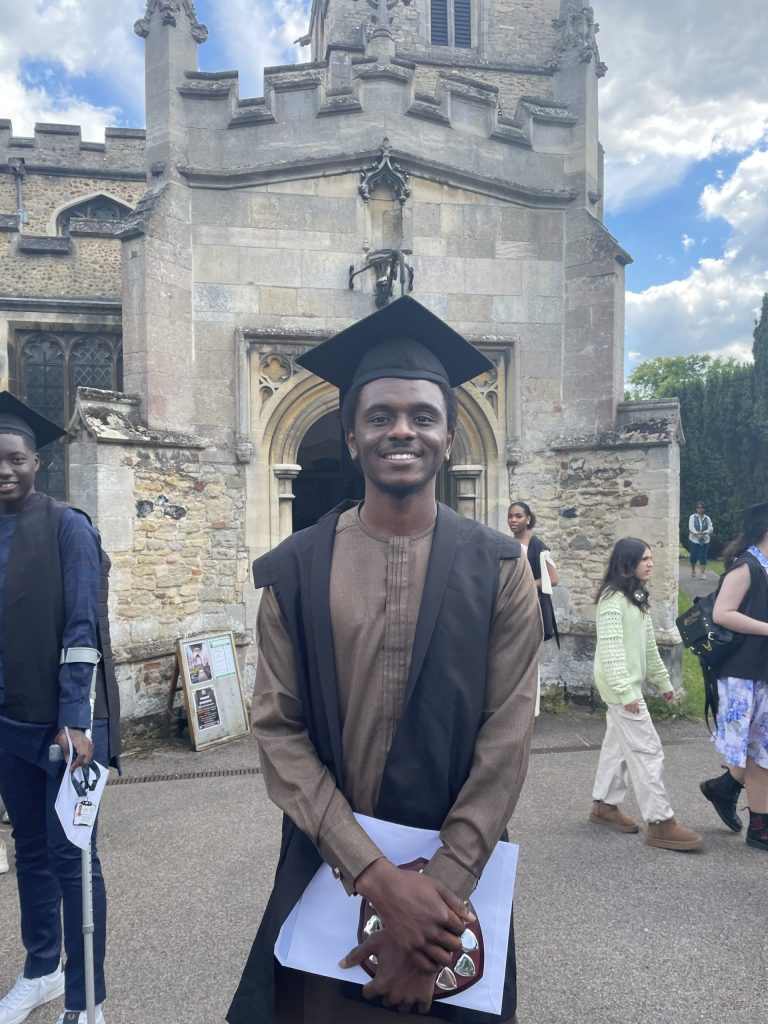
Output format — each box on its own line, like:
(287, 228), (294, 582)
(171, 51), (587, 205)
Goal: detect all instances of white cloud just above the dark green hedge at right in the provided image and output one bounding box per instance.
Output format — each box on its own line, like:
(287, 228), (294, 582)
(627, 150), (768, 360)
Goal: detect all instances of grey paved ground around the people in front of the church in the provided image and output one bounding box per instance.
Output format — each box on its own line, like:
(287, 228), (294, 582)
(0, 710), (768, 1024)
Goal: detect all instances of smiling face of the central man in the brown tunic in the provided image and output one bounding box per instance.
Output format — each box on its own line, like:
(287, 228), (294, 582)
(346, 377), (454, 497)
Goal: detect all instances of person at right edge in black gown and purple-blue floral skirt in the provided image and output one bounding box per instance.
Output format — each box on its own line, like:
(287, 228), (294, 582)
(700, 502), (768, 851)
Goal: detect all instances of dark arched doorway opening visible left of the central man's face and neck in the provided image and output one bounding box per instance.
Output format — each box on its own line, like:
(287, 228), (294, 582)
(293, 410), (362, 532)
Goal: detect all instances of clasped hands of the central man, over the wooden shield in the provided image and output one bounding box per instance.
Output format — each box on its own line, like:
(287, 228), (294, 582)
(340, 857), (475, 1014)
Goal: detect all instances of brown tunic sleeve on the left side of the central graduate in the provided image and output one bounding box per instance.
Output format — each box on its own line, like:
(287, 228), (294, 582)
(251, 590), (382, 892)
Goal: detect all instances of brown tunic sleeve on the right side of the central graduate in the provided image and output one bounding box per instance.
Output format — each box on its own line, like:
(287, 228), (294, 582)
(425, 558), (543, 899)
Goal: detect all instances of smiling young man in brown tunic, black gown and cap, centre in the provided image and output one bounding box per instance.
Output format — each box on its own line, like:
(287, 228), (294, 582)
(227, 297), (542, 1024)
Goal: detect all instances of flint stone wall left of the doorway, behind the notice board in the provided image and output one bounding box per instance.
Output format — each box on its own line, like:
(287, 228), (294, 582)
(70, 389), (252, 720)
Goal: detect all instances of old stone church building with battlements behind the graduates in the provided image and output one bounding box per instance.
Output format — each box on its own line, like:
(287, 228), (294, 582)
(0, 0), (680, 719)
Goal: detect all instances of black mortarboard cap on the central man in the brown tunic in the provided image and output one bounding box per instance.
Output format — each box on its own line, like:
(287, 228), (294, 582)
(296, 295), (494, 395)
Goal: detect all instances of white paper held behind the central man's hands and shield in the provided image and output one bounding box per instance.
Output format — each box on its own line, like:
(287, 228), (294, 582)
(274, 814), (518, 1014)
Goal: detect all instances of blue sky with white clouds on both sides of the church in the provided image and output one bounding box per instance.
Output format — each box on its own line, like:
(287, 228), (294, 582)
(0, 0), (768, 370)
